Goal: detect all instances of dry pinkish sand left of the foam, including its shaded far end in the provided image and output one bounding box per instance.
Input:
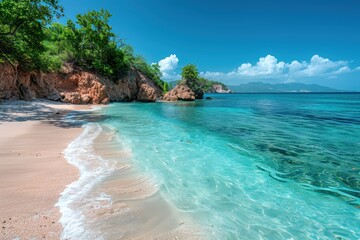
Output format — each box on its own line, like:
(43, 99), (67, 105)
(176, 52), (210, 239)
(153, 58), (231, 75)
(0, 102), (89, 239)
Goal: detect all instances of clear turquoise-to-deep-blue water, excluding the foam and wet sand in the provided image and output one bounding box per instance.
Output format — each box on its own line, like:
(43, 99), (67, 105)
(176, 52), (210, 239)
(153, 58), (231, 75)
(102, 94), (360, 239)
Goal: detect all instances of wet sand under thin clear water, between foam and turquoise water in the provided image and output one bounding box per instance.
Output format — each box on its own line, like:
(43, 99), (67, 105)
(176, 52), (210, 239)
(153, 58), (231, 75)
(68, 126), (208, 240)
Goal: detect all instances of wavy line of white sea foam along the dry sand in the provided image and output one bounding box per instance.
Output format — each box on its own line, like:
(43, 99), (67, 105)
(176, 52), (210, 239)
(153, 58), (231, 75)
(55, 123), (113, 239)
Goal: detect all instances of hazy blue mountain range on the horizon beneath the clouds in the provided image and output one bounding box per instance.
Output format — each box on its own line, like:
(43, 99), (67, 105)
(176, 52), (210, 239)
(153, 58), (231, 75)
(227, 82), (345, 93)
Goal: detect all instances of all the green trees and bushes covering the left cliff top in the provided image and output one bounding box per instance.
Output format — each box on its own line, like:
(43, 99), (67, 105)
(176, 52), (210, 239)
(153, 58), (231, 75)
(0, 0), (168, 91)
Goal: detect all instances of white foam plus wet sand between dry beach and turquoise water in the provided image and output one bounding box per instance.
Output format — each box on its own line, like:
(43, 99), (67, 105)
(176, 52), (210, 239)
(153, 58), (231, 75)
(57, 119), (203, 239)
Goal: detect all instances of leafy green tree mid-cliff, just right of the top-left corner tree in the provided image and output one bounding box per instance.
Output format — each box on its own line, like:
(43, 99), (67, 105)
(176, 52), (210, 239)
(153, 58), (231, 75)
(67, 9), (128, 80)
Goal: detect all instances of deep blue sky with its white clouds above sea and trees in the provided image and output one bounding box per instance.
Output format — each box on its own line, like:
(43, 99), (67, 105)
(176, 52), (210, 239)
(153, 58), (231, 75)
(61, 0), (360, 91)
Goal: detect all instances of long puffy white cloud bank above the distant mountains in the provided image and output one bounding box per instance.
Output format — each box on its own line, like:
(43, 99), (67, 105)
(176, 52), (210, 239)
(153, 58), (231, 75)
(201, 55), (352, 81)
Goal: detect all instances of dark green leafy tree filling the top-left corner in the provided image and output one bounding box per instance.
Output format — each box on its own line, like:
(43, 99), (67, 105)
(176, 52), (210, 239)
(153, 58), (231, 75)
(0, 0), (63, 69)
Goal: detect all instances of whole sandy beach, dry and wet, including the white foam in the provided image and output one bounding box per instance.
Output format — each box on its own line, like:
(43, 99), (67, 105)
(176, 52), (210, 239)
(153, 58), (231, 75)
(0, 101), (204, 239)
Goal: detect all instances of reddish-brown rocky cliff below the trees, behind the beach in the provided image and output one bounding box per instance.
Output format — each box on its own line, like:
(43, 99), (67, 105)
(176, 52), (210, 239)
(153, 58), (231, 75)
(0, 64), (162, 104)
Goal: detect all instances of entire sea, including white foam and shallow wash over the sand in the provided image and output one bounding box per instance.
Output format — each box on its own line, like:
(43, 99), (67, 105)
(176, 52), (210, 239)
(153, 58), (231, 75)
(57, 93), (360, 240)
